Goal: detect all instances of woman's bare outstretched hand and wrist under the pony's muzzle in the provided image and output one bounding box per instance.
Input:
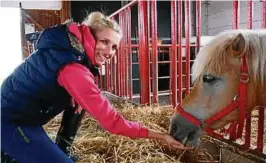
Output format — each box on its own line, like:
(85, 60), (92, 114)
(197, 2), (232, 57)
(148, 129), (192, 149)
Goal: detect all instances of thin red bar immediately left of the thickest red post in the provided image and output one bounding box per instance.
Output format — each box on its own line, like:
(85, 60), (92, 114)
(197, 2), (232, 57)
(126, 7), (132, 100)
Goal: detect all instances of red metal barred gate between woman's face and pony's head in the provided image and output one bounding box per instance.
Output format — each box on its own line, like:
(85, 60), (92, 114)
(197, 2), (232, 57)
(101, 1), (201, 105)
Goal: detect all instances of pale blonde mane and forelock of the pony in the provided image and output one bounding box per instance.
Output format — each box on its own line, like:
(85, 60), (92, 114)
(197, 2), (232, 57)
(192, 29), (266, 85)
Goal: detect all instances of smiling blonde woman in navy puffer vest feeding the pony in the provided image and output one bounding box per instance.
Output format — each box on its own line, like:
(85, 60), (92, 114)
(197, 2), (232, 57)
(1, 12), (190, 163)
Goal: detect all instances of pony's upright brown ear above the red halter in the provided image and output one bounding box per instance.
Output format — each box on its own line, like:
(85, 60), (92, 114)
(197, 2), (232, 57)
(230, 33), (246, 57)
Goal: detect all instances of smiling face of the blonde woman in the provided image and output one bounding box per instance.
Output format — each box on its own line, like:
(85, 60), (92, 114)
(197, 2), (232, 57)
(94, 28), (121, 66)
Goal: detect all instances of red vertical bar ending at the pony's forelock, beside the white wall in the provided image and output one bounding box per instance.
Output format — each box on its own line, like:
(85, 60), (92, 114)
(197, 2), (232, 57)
(196, 0), (201, 52)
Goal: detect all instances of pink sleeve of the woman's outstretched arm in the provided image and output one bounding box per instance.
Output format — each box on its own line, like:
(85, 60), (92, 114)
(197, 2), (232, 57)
(58, 63), (148, 138)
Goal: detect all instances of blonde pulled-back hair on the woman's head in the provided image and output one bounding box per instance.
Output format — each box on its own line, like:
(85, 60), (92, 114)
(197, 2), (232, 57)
(82, 11), (122, 37)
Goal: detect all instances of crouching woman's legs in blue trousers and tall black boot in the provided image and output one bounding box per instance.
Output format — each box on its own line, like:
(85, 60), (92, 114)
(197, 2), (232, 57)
(1, 108), (85, 163)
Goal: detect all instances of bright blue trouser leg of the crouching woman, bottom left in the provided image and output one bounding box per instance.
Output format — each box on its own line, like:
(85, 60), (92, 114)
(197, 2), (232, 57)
(1, 121), (73, 163)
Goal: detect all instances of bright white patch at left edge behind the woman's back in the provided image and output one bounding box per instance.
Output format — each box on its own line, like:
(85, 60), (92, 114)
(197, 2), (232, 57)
(0, 7), (22, 85)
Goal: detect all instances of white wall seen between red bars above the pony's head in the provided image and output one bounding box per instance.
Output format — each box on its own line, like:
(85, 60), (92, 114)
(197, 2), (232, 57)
(201, 0), (262, 36)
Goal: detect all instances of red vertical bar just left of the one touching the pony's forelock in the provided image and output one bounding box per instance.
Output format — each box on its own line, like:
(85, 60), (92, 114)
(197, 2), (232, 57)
(185, 0), (190, 95)
